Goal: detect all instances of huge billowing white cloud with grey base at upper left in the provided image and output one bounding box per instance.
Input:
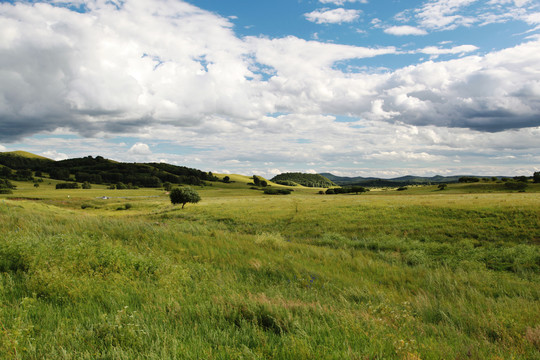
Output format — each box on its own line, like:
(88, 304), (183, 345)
(0, 0), (252, 138)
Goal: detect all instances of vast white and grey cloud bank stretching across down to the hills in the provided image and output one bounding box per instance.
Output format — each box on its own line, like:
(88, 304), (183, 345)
(0, 0), (540, 176)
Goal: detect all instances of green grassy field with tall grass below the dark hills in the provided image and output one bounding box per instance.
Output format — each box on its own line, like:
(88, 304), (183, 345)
(0, 181), (540, 360)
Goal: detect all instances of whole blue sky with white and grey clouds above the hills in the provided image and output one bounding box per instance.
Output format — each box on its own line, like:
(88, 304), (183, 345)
(0, 0), (540, 178)
